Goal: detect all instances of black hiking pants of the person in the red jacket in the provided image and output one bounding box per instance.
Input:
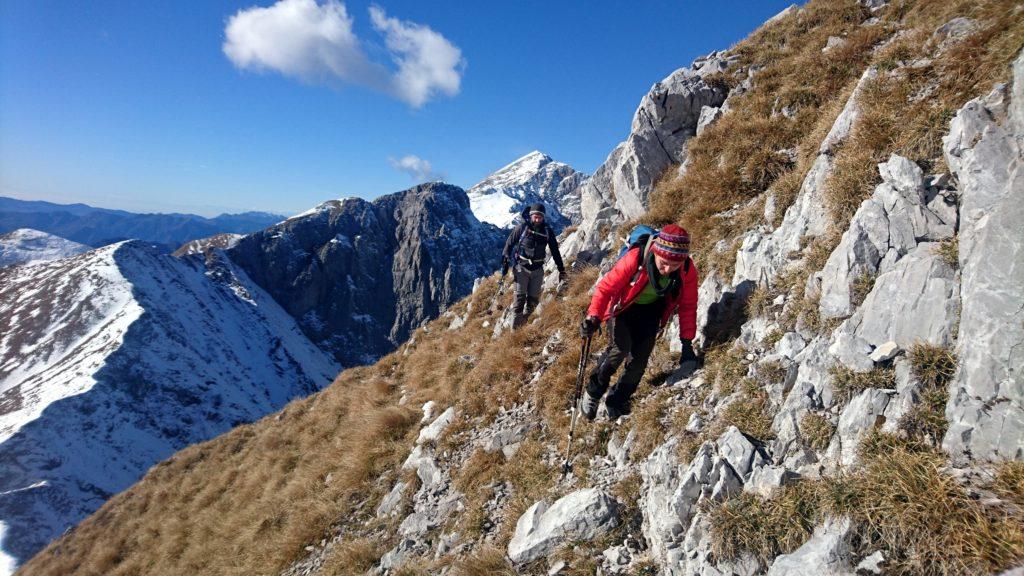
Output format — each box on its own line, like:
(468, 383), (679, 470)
(587, 298), (665, 414)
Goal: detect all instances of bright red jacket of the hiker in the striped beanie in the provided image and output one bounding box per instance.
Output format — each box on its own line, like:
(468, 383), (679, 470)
(587, 243), (698, 340)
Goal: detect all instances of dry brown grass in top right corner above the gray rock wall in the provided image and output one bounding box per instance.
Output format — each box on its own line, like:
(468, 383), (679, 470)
(826, 0), (1024, 222)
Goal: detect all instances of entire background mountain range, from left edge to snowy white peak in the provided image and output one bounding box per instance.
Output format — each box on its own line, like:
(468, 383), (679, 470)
(0, 155), (579, 574)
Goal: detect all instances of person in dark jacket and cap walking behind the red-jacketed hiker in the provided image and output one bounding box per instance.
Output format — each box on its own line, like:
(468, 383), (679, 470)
(502, 204), (565, 328)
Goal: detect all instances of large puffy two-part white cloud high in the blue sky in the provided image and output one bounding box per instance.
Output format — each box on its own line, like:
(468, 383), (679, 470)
(223, 0), (465, 108)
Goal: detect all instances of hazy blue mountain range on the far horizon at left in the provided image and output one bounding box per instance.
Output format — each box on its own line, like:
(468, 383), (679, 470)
(0, 197), (285, 250)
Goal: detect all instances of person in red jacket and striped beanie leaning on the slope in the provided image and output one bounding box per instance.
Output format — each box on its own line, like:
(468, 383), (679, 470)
(580, 224), (698, 421)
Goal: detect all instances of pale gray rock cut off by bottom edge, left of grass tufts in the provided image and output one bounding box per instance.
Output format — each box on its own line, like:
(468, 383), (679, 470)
(768, 518), (854, 576)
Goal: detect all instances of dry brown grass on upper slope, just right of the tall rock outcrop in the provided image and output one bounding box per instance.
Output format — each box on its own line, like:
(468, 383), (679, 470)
(650, 1), (886, 278)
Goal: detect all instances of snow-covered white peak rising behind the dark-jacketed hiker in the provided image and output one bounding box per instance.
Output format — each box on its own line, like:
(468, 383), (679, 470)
(466, 151), (588, 230)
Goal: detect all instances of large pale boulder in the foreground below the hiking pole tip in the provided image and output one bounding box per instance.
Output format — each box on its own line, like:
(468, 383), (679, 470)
(508, 488), (618, 564)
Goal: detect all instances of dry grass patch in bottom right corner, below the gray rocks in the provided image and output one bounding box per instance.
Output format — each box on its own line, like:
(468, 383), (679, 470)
(709, 444), (1024, 575)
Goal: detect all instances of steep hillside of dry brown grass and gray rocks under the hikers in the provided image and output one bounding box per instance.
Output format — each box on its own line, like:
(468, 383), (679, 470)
(20, 0), (1024, 576)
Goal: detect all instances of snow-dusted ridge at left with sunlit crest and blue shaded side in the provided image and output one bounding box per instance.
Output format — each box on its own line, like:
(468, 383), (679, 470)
(0, 242), (338, 571)
